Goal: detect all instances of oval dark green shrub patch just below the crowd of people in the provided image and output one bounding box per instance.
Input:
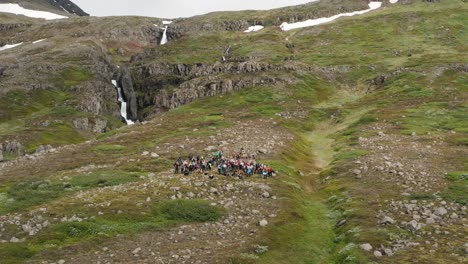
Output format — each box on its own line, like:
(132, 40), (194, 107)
(161, 200), (224, 222)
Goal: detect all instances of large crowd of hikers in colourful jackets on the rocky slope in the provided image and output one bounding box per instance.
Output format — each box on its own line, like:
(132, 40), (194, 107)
(174, 149), (275, 179)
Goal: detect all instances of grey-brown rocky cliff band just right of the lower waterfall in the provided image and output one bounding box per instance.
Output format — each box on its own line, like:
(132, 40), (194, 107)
(132, 61), (301, 116)
